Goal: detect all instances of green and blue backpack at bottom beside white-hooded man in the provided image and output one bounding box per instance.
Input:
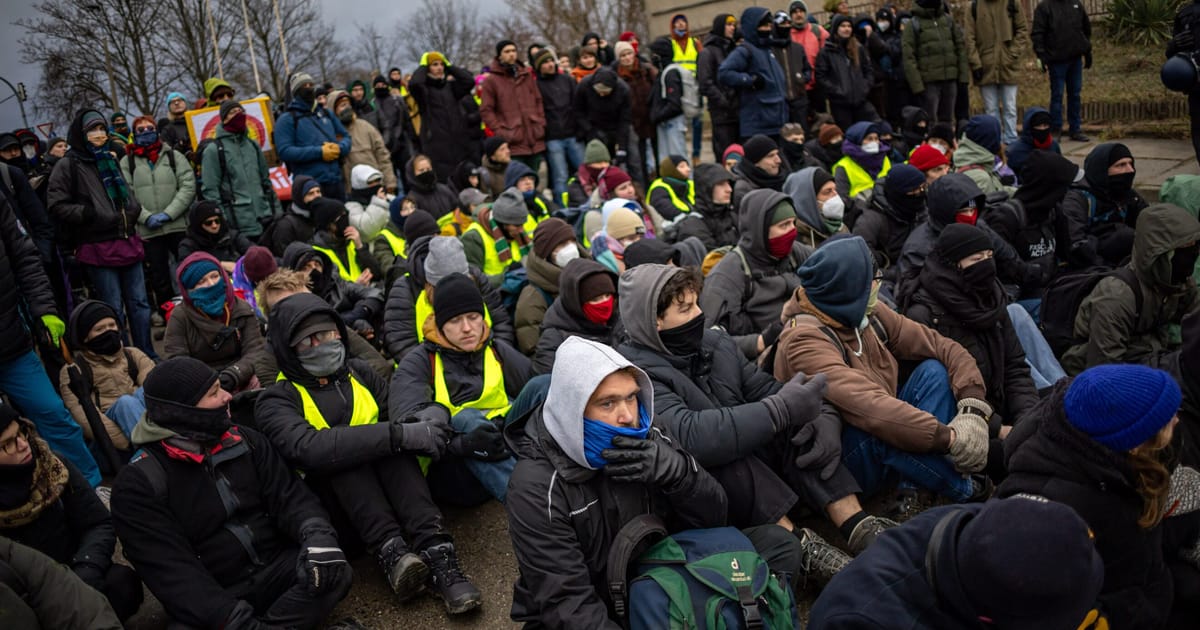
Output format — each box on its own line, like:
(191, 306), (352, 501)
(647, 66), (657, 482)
(608, 515), (799, 630)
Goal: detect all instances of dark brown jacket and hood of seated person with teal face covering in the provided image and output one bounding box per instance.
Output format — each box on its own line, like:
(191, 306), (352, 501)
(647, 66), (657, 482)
(162, 252), (265, 388)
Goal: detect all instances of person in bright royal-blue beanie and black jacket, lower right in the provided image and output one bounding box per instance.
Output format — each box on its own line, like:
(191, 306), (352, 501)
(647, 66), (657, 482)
(997, 365), (1180, 629)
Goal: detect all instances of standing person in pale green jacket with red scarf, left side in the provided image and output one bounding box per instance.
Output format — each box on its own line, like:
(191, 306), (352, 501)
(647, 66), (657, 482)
(120, 116), (196, 317)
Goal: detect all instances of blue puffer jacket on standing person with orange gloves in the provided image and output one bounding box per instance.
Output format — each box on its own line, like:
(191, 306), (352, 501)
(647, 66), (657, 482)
(275, 100), (350, 184)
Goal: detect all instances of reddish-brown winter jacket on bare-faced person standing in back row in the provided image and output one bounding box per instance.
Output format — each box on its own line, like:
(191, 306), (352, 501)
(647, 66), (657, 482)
(479, 60), (546, 156)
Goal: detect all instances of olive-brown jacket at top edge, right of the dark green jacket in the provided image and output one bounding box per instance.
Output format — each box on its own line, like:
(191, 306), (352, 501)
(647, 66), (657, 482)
(962, 0), (1030, 85)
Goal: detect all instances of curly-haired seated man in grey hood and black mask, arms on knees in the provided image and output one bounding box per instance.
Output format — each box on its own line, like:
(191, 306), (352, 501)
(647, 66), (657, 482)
(617, 265), (895, 561)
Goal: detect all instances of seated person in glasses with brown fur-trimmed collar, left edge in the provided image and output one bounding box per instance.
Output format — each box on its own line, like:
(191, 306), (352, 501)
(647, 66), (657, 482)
(0, 402), (142, 628)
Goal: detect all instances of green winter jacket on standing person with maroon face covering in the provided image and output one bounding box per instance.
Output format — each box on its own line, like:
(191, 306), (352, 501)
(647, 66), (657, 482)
(200, 127), (278, 236)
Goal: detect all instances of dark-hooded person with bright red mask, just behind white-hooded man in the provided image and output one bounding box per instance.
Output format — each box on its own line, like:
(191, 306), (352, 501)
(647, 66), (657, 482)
(533, 258), (620, 374)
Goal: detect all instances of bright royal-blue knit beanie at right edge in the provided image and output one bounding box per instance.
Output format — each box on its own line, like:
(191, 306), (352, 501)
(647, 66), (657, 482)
(1063, 365), (1183, 452)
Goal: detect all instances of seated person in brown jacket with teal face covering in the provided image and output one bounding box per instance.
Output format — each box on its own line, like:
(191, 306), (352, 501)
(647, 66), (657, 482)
(162, 252), (264, 394)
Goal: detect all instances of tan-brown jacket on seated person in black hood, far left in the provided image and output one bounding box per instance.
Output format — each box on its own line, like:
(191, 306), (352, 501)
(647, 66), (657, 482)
(59, 348), (154, 450)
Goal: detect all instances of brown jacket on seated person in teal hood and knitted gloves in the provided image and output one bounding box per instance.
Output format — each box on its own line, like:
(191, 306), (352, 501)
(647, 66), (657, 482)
(775, 287), (986, 452)
